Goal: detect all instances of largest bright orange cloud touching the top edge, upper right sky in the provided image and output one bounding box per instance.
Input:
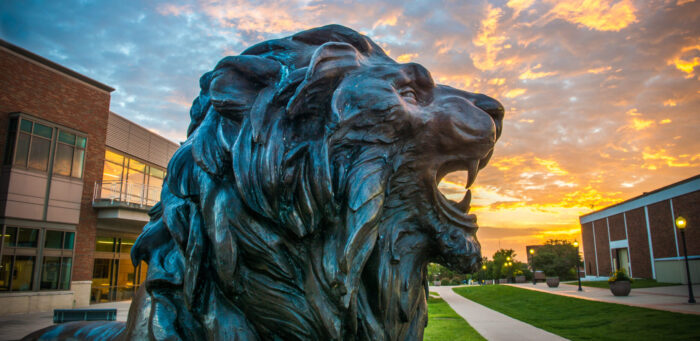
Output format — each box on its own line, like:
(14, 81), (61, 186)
(547, 0), (637, 31)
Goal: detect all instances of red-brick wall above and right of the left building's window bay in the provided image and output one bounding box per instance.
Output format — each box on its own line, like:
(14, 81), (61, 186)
(0, 47), (110, 281)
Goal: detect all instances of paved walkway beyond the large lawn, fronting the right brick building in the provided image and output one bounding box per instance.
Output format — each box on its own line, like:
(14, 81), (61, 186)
(507, 283), (700, 315)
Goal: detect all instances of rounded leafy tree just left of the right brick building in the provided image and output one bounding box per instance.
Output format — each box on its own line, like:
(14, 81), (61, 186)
(532, 239), (579, 279)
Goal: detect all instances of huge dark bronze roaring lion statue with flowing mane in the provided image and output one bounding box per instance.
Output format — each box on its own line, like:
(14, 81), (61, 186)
(23, 25), (504, 340)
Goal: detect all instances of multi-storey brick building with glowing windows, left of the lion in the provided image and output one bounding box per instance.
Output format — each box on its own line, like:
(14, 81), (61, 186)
(0, 40), (178, 315)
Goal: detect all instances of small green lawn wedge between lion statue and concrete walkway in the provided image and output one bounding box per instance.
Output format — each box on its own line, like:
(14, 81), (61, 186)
(423, 298), (486, 341)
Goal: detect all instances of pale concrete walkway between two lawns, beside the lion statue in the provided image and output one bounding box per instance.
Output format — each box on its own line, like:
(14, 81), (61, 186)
(430, 286), (566, 341)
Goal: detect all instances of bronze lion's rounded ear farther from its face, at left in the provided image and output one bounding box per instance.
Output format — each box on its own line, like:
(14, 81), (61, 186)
(209, 55), (281, 122)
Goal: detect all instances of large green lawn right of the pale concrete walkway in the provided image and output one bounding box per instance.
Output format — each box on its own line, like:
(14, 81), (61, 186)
(454, 285), (700, 340)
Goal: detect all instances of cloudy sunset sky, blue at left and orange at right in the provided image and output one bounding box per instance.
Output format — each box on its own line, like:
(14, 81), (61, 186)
(0, 0), (700, 260)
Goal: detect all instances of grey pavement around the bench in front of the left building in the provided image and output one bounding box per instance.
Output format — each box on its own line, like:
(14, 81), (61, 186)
(0, 301), (131, 341)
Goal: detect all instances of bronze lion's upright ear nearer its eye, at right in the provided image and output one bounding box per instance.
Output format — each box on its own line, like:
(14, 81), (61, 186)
(287, 42), (363, 120)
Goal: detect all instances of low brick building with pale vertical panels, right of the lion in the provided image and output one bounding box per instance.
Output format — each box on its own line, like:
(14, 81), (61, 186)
(579, 175), (700, 283)
